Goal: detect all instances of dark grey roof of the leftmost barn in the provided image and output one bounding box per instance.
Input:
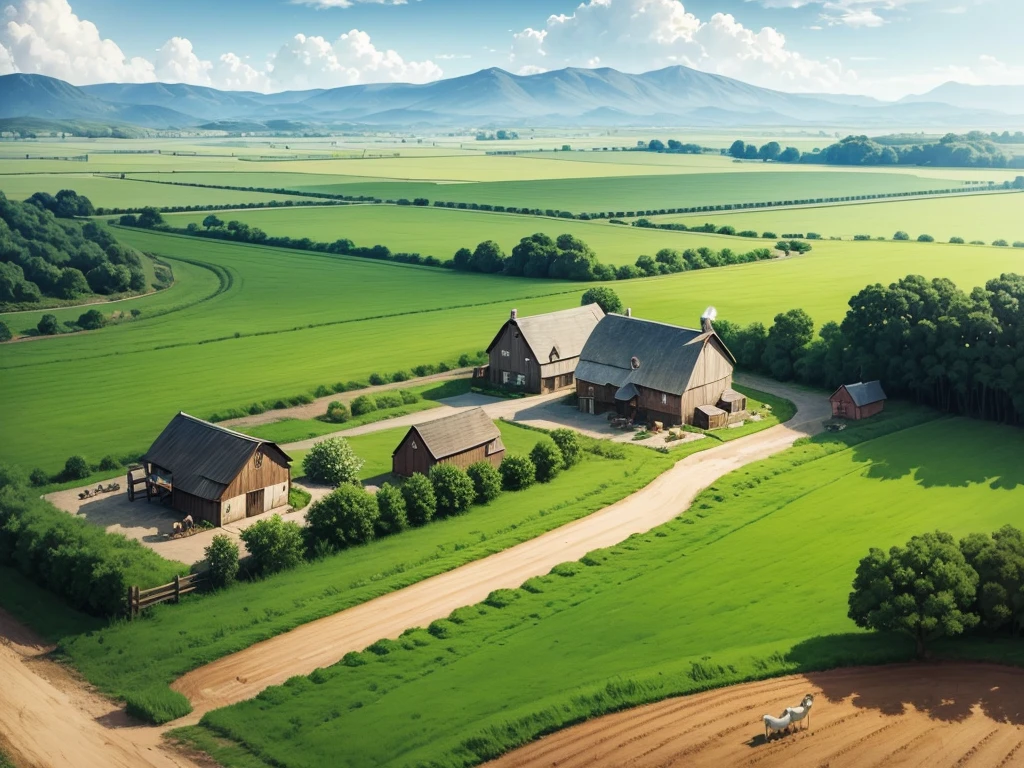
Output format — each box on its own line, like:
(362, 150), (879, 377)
(142, 413), (292, 500)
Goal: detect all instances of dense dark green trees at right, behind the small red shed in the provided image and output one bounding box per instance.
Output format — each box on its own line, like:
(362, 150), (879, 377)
(715, 273), (1024, 425)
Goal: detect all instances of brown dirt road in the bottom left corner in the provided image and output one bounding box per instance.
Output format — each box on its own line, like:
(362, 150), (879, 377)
(0, 610), (199, 768)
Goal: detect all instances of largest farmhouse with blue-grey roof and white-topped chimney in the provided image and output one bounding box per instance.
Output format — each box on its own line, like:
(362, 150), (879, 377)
(575, 310), (745, 426)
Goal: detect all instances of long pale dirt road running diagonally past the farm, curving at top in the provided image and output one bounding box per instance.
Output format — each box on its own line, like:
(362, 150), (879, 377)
(165, 377), (830, 725)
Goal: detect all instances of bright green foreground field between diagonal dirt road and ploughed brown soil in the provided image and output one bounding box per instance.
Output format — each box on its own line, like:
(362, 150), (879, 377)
(182, 409), (1024, 768)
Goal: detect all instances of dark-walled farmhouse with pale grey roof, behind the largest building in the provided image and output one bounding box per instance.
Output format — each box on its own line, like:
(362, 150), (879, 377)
(487, 304), (604, 393)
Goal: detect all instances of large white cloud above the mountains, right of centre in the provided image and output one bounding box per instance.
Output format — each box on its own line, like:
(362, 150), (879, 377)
(510, 0), (856, 90)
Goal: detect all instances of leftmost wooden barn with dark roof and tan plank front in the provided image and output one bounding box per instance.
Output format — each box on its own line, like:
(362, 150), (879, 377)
(142, 413), (292, 525)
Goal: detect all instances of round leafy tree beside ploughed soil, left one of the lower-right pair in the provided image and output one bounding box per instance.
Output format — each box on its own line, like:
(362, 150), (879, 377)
(849, 531), (978, 658)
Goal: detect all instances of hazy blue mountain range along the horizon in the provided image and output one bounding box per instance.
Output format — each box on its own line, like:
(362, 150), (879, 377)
(0, 67), (1024, 132)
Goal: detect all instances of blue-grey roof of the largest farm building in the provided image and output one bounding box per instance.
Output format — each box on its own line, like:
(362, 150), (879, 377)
(575, 314), (735, 394)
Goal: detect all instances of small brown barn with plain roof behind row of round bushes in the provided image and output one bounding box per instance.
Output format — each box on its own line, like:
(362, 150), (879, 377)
(391, 408), (505, 477)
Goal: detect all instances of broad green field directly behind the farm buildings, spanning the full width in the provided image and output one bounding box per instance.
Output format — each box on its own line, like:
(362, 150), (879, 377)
(0, 225), (1020, 472)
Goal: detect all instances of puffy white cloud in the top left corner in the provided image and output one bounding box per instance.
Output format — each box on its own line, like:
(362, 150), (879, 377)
(0, 0), (155, 84)
